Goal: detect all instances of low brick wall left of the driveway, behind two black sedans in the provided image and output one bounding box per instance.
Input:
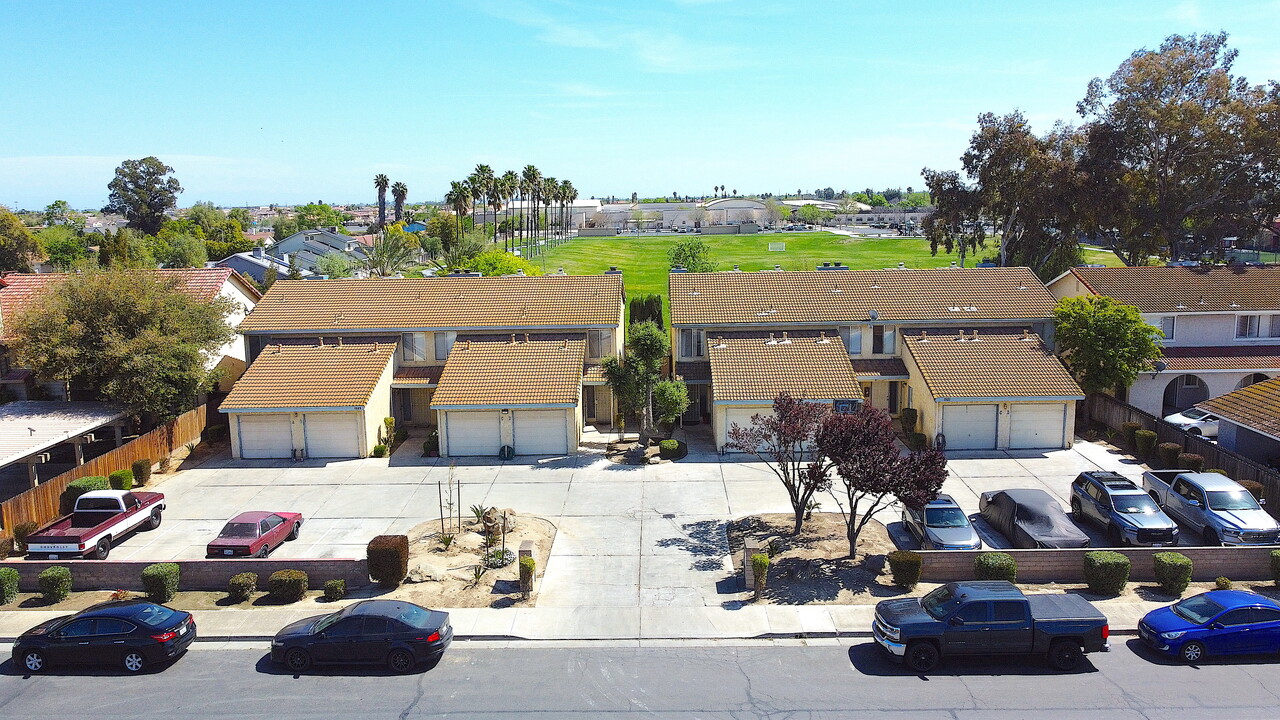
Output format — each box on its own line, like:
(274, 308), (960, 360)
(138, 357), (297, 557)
(0, 559), (370, 592)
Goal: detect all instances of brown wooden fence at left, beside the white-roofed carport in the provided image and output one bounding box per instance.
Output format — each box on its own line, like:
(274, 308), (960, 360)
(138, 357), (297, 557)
(0, 405), (209, 534)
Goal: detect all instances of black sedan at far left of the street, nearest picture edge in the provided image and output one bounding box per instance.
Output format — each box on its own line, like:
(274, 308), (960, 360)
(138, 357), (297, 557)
(13, 600), (196, 674)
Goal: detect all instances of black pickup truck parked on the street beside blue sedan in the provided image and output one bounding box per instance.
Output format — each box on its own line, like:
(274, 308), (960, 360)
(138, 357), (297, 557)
(872, 580), (1110, 673)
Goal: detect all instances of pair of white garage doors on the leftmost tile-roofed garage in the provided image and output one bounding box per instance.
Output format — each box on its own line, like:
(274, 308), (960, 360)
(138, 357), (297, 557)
(237, 413), (361, 459)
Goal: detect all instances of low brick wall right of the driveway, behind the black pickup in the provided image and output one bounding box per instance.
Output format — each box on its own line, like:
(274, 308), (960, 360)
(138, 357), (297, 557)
(920, 547), (1276, 583)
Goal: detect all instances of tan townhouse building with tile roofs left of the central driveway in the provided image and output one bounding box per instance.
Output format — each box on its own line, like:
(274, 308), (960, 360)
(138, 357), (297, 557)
(221, 274), (623, 457)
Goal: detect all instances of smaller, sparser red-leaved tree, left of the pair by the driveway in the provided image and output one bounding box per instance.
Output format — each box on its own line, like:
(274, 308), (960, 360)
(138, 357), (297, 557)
(724, 393), (831, 534)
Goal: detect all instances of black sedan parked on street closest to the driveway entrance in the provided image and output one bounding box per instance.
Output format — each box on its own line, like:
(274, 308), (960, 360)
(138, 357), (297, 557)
(271, 600), (453, 673)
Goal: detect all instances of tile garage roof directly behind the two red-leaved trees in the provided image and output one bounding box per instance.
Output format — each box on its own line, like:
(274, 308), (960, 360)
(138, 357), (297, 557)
(707, 334), (863, 402)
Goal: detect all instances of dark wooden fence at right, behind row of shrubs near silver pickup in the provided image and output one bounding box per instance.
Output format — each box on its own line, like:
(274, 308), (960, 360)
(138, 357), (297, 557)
(1084, 395), (1280, 518)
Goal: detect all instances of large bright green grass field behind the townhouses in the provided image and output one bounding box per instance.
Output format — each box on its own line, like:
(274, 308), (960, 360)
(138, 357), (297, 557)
(532, 232), (1121, 296)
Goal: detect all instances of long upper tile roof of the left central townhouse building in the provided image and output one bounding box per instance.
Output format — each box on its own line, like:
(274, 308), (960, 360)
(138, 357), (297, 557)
(241, 275), (622, 332)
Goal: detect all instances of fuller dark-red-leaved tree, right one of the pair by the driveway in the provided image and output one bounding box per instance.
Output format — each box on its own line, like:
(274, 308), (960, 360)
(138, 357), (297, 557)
(806, 406), (947, 557)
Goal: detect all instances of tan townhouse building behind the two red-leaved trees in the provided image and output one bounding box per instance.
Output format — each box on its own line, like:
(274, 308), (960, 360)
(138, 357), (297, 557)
(669, 268), (1083, 450)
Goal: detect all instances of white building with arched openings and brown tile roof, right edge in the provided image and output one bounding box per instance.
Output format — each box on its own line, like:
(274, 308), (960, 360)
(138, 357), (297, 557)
(1048, 265), (1280, 416)
